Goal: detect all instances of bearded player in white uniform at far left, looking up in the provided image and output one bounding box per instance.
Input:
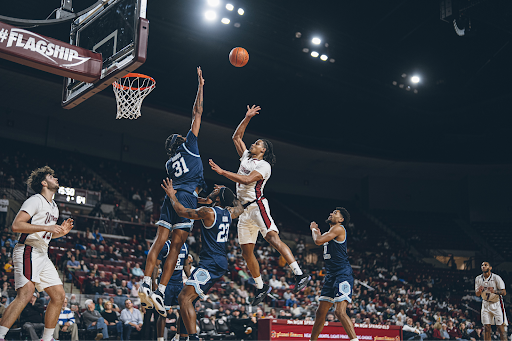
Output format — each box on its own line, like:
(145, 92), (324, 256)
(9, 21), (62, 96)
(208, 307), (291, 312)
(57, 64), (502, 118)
(0, 166), (73, 341)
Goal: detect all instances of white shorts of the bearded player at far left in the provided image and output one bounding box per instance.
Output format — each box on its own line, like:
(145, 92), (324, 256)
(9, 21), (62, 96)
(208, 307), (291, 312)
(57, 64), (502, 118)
(12, 244), (62, 291)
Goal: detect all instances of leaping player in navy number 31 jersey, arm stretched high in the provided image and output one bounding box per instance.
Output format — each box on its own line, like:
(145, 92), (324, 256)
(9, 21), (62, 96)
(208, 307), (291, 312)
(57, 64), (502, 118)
(139, 67), (206, 317)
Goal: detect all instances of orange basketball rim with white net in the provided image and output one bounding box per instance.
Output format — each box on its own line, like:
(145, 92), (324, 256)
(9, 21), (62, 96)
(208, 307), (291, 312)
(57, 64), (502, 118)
(112, 73), (156, 120)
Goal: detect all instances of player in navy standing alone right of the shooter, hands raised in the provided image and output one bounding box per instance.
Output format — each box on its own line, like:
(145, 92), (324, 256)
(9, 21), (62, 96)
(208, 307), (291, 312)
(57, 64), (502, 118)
(310, 207), (358, 341)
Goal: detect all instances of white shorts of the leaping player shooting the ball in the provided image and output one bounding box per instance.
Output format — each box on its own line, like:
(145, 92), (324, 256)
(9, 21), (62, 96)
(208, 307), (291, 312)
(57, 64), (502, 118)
(238, 199), (279, 244)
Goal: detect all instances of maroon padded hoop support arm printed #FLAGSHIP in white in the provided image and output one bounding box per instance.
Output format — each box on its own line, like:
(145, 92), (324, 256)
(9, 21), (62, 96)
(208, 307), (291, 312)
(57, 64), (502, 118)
(0, 22), (103, 83)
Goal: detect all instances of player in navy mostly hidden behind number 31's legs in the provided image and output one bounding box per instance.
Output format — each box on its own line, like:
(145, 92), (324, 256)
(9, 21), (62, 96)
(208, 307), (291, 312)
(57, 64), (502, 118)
(153, 240), (191, 341)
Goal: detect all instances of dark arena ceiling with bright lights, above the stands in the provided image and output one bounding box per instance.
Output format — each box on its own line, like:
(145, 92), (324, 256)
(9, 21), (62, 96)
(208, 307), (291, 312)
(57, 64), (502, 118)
(0, 0), (512, 164)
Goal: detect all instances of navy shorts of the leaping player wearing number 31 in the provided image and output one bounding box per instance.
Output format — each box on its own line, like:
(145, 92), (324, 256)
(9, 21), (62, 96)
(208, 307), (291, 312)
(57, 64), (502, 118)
(156, 190), (197, 231)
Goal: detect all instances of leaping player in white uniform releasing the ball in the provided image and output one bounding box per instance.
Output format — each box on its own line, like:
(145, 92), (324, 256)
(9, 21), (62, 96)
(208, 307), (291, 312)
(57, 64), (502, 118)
(210, 105), (311, 305)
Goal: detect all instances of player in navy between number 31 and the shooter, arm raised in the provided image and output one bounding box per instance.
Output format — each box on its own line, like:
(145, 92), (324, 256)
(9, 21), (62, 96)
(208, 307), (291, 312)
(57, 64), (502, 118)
(162, 179), (244, 341)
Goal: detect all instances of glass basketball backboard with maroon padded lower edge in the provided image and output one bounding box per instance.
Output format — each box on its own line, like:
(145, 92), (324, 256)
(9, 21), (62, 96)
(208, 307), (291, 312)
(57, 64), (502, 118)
(62, 0), (149, 109)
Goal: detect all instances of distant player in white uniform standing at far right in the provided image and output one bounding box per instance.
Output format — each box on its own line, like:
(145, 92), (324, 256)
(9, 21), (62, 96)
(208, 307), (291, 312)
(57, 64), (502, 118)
(475, 262), (508, 341)
